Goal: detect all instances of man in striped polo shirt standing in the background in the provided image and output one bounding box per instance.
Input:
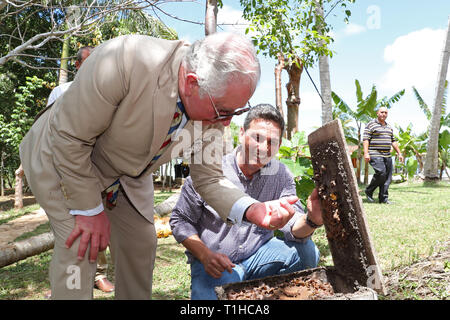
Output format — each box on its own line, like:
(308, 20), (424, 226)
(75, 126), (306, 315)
(363, 107), (403, 204)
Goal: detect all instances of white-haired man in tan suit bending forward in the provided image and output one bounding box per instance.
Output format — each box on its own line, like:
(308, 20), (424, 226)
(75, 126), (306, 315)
(20, 33), (297, 299)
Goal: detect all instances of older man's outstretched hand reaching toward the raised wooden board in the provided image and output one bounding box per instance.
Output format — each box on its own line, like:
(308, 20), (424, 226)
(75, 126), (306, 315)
(246, 196), (298, 230)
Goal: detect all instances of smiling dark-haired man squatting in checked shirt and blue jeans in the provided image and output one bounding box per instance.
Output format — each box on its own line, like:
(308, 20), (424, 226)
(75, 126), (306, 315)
(170, 104), (323, 300)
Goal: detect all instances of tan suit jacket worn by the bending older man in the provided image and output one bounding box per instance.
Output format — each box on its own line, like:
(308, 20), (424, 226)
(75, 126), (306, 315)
(20, 35), (245, 221)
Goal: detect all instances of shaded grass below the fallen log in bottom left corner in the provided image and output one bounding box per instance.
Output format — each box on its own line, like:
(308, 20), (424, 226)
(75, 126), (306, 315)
(0, 250), (53, 300)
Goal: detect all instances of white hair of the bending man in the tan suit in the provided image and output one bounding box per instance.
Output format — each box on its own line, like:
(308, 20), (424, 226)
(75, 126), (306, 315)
(184, 32), (261, 98)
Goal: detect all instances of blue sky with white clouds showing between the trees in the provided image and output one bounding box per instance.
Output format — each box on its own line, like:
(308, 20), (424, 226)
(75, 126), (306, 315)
(153, 0), (450, 133)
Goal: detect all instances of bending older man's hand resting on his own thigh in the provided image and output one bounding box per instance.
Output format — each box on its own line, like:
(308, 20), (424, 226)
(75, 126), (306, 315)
(66, 211), (111, 263)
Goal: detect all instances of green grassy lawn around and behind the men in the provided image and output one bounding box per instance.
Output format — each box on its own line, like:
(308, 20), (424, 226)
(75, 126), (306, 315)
(0, 182), (450, 300)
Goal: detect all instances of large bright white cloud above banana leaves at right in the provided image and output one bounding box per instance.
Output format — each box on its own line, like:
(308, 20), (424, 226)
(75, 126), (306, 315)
(377, 28), (449, 133)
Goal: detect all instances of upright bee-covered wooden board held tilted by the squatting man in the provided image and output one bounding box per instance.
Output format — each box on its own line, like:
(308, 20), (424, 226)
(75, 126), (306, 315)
(308, 120), (386, 294)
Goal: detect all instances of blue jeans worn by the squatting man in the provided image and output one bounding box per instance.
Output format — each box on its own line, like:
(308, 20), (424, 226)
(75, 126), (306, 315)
(191, 237), (320, 300)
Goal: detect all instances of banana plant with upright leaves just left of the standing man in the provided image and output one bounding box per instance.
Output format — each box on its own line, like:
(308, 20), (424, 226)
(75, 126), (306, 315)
(331, 79), (405, 184)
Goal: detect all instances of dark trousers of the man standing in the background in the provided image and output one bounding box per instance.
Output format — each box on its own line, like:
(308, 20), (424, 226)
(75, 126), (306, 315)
(366, 157), (392, 203)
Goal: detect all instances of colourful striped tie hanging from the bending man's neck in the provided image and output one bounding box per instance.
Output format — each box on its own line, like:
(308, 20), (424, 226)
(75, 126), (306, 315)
(105, 101), (187, 210)
